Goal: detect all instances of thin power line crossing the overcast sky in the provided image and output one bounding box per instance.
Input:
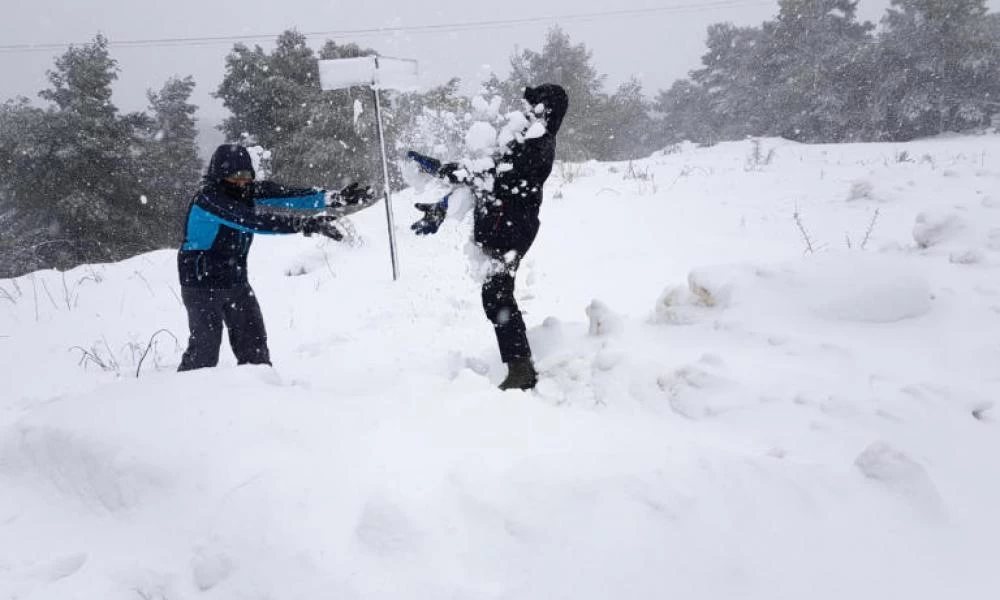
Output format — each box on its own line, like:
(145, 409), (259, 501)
(0, 0), (774, 54)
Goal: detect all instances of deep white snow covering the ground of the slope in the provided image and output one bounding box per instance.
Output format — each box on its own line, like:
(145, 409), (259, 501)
(0, 136), (1000, 600)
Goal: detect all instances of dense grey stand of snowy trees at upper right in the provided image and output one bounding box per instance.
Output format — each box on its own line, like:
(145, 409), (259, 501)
(653, 0), (1000, 142)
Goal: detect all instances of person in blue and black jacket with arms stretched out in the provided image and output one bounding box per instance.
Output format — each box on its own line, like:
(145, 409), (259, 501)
(177, 144), (370, 371)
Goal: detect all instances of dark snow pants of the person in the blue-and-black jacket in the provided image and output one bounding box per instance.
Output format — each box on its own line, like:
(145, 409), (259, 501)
(177, 284), (271, 371)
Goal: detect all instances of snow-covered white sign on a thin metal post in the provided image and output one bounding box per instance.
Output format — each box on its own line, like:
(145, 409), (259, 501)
(319, 56), (419, 280)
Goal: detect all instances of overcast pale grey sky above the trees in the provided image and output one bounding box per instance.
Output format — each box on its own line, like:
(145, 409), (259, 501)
(0, 0), (1000, 121)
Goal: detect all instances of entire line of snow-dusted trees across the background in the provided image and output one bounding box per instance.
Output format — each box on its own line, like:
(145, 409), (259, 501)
(0, 0), (1000, 277)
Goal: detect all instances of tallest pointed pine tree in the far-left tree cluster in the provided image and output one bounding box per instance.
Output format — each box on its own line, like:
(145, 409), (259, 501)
(31, 35), (151, 267)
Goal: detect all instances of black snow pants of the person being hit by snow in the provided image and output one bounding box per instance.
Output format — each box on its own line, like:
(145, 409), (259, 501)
(480, 221), (538, 363)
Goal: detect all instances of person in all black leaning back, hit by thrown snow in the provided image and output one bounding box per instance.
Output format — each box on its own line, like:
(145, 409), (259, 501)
(409, 83), (569, 390)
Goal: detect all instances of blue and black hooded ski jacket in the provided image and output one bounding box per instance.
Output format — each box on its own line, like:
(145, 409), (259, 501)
(177, 145), (326, 289)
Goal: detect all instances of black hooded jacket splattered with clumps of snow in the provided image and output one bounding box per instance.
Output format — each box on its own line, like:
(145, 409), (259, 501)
(448, 83), (569, 253)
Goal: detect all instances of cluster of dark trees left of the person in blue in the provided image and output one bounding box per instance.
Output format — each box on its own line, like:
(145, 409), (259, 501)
(0, 35), (201, 276)
